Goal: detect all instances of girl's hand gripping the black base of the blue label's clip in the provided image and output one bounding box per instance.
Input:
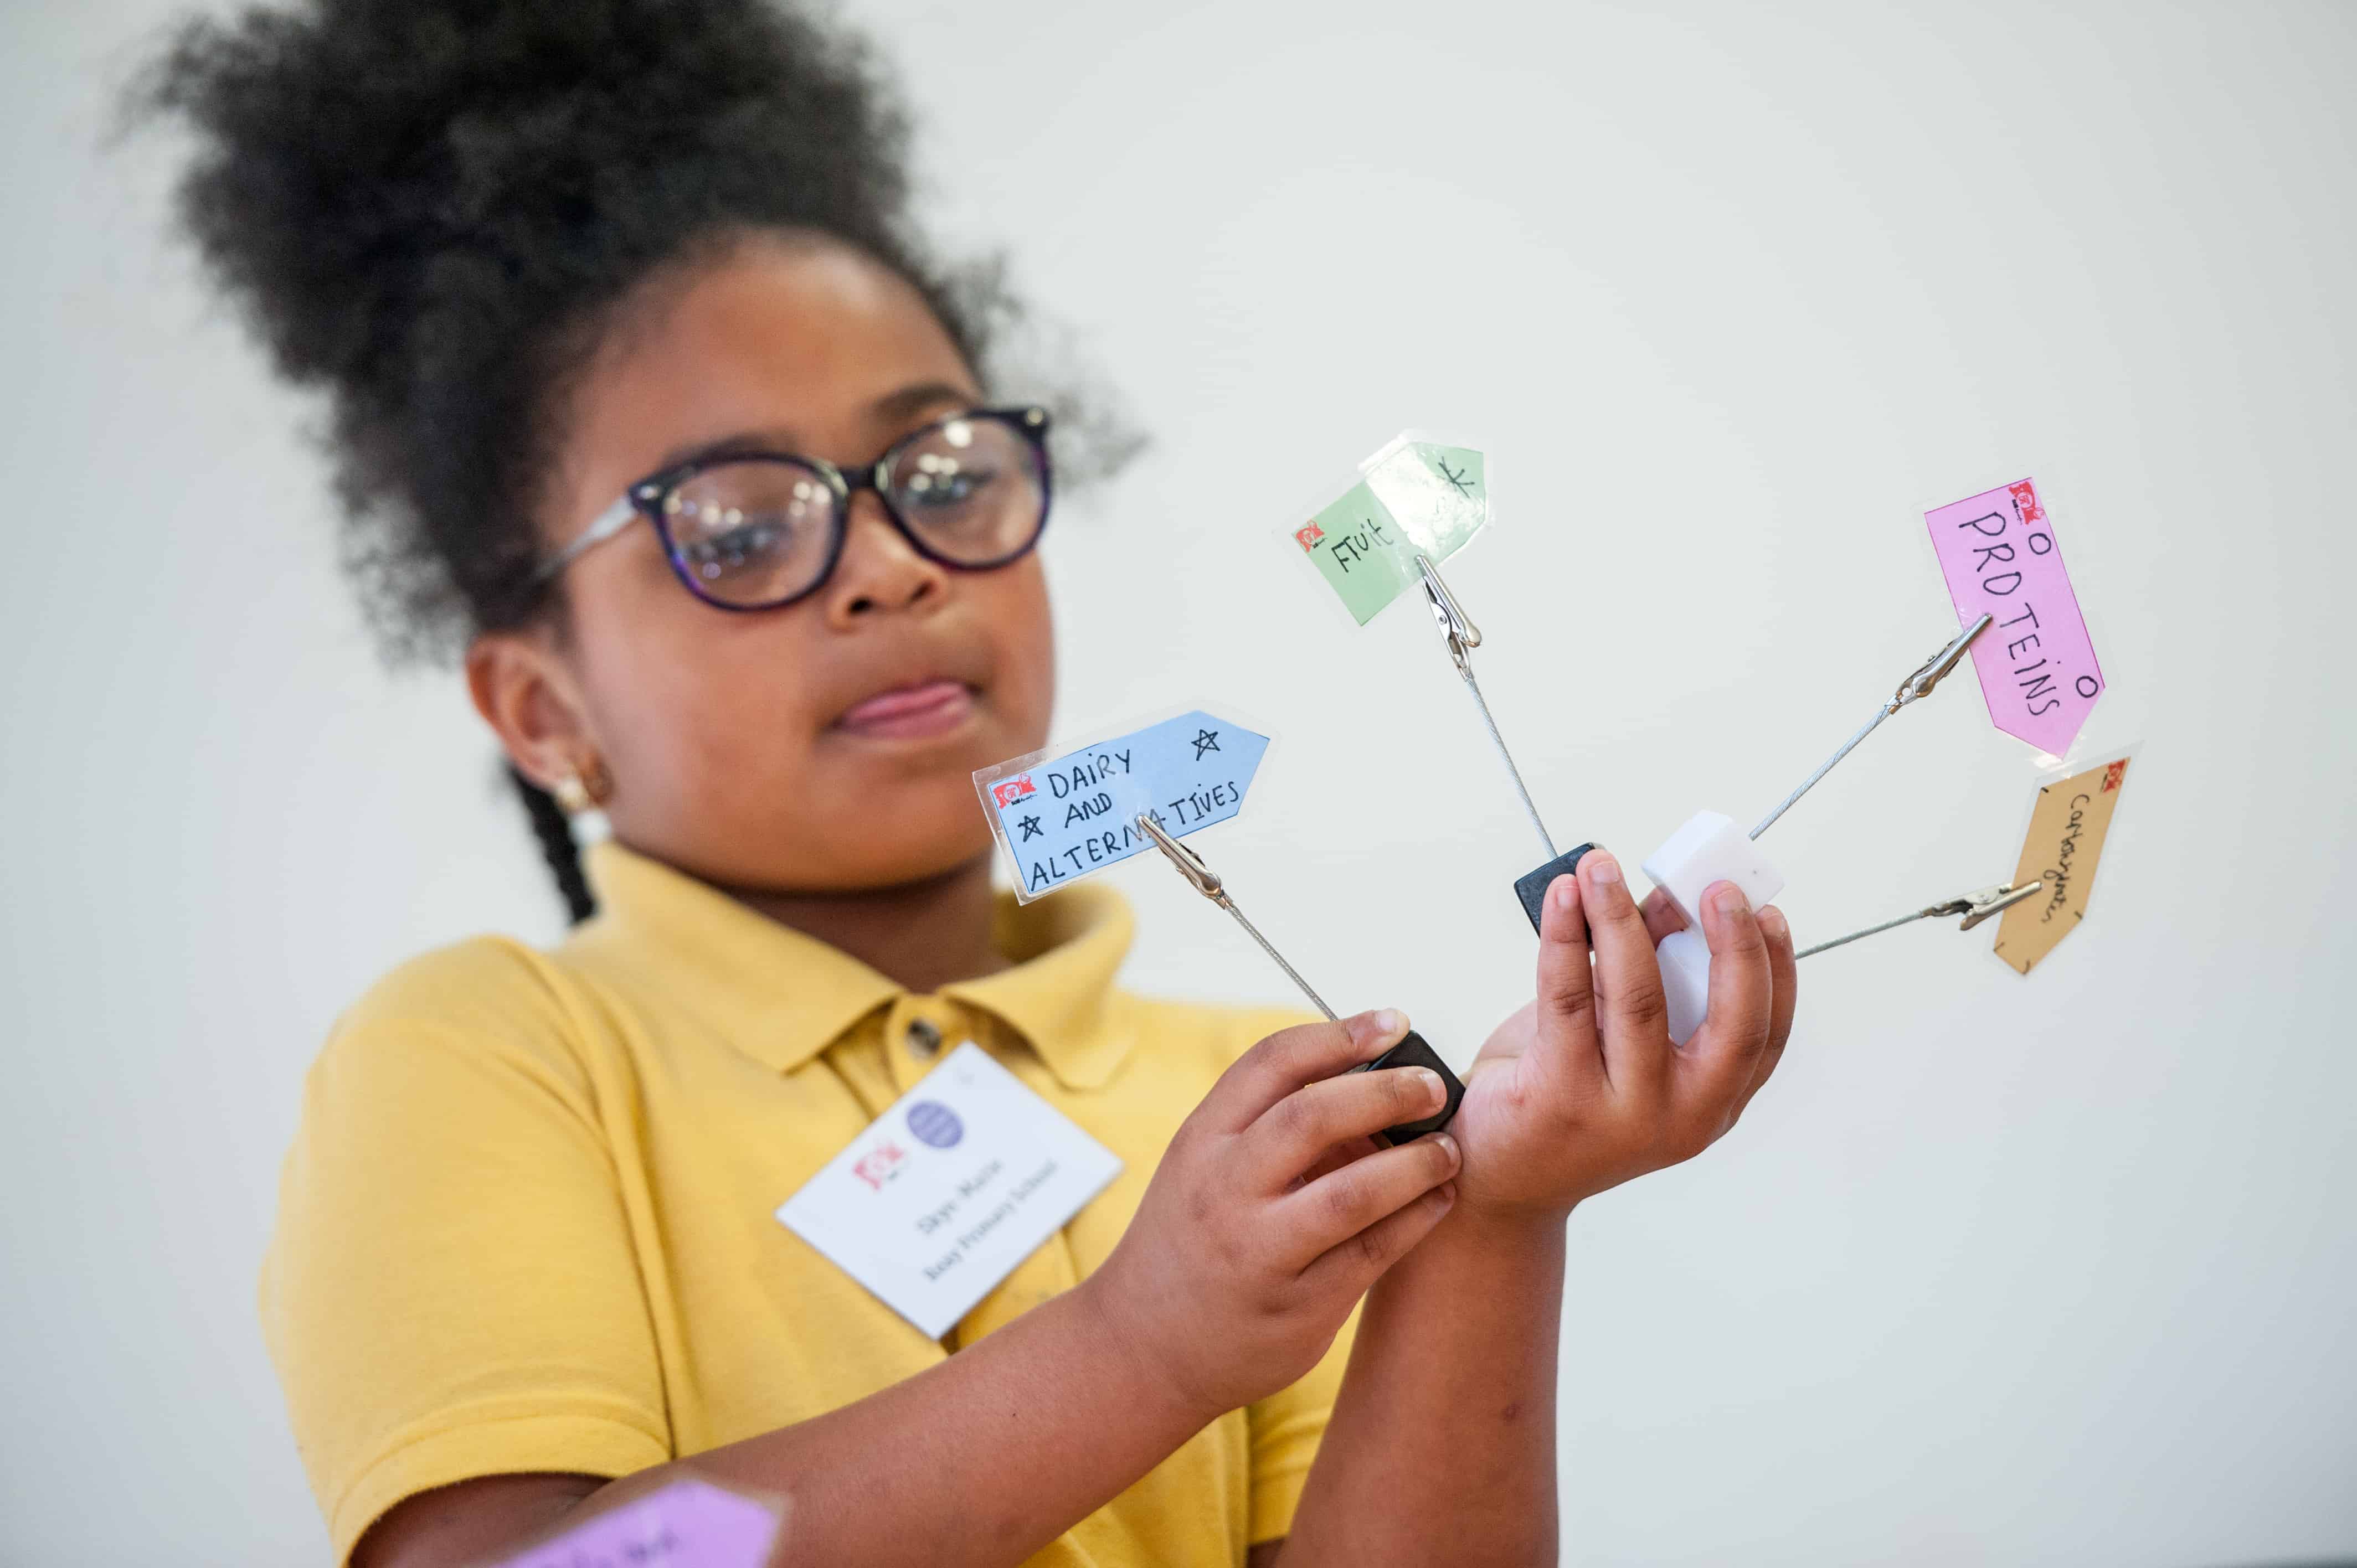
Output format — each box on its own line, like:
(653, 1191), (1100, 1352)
(1082, 1009), (1457, 1422)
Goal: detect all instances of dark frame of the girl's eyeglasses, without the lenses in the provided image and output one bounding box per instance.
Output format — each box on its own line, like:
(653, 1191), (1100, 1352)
(533, 405), (1056, 613)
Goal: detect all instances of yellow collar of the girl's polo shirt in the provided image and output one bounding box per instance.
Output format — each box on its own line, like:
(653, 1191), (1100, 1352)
(565, 839), (1136, 1089)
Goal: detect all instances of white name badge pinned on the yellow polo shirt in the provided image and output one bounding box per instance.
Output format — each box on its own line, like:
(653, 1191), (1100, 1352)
(778, 1040), (1122, 1339)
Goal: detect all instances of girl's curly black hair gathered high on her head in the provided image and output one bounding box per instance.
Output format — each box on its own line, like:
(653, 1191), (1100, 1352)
(130, 0), (1139, 920)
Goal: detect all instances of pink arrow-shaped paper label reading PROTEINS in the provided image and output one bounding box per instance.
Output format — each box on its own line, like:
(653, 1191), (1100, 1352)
(1923, 479), (2102, 757)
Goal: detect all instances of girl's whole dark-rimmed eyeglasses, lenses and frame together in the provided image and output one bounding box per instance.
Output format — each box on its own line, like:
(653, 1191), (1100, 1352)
(533, 408), (1049, 611)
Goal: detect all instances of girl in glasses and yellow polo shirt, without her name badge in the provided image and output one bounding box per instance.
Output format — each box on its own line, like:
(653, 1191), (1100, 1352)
(153, 0), (1794, 1568)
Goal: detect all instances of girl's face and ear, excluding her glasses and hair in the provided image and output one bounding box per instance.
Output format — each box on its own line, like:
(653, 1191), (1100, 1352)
(483, 240), (1053, 891)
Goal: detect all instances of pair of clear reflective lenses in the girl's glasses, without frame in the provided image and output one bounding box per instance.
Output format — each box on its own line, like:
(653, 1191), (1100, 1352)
(662, 417), (1047, 606)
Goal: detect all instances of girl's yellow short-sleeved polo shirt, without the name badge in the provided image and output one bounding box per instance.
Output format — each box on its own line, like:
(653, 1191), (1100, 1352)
(261, 844), (1348, 1568)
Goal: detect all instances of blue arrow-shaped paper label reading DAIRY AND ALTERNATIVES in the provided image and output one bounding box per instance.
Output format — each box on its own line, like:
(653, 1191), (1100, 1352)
(974, 710), (1268, 899)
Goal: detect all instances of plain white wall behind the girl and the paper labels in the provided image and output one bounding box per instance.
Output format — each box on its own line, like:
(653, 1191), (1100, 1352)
(0, 0), (2357, 1566)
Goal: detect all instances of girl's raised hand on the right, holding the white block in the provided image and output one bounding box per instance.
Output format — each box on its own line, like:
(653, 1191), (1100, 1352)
(1449, 849), (1796, 1219)
